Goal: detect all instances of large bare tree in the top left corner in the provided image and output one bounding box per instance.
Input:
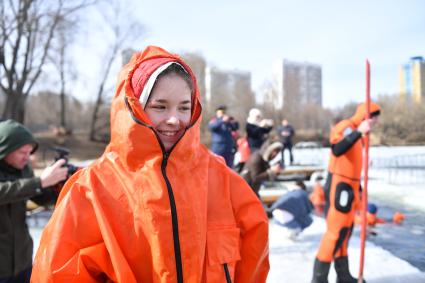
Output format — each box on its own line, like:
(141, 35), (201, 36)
(0, 0), (94, 122)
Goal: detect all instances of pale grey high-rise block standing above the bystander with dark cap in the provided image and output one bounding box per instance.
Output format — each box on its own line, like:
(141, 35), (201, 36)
(273, 59), (322, 109)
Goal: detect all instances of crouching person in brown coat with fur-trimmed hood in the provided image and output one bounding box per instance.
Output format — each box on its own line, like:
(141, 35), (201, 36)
(241, 141), (283, 198)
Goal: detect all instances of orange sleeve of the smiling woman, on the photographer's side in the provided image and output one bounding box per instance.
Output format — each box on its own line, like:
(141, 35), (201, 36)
(31, 179), (122, 283)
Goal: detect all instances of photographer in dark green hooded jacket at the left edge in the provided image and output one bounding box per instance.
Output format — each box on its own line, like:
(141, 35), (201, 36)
(0, 120), (68, 283)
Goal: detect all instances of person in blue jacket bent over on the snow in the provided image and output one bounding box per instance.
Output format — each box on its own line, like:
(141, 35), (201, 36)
(270, 181), (313, 239)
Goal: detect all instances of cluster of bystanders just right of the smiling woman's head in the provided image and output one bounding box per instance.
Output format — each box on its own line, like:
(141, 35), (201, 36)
(208, 105), (295, 203)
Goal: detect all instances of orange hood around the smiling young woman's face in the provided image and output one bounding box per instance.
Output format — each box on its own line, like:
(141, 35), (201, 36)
(106, 46), (202, 172)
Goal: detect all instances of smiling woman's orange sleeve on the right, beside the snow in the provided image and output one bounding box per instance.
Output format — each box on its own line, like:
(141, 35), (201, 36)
(230, 176), (270, 283)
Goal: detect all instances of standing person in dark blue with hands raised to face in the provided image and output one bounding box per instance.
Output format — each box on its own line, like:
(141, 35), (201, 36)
(208, 105), (239, 168)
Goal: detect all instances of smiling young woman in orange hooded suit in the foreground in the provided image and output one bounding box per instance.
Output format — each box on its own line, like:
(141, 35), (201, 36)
(31, 46), (269, 283)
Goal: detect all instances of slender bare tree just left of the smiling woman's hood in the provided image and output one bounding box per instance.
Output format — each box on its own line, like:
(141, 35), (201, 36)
(89, 1), (144, 141)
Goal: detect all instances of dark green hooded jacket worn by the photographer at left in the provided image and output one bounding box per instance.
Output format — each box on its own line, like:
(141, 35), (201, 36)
(0, 120), (52, 279)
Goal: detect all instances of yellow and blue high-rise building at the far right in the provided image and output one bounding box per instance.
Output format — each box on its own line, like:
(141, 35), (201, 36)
(400, 56), (425, 103)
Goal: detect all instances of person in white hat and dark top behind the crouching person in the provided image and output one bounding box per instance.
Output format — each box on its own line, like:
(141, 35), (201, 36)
(245, 108), (273, 152)
